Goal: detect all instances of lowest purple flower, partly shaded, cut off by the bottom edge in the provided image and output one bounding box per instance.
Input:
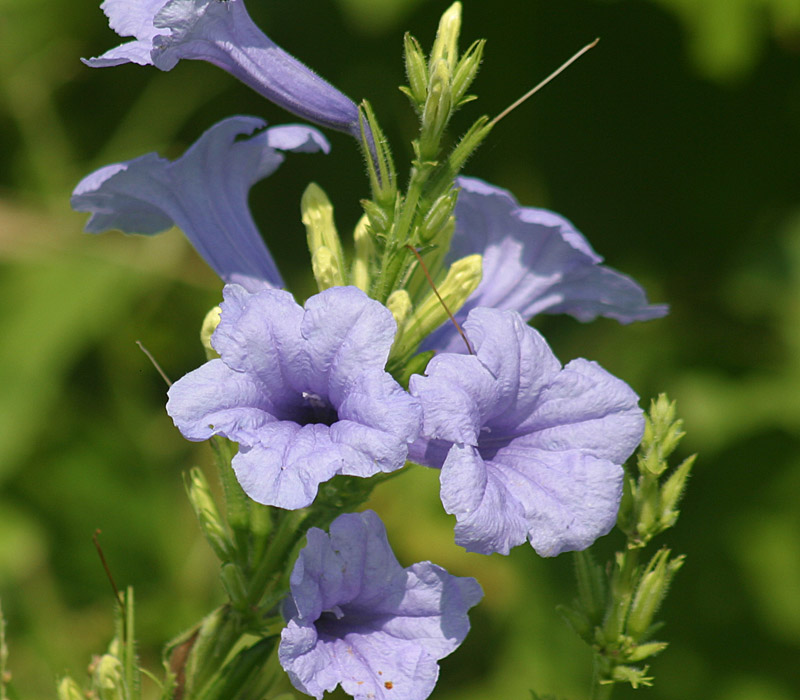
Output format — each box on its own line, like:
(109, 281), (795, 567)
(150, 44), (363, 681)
(278, 511), (483, 700)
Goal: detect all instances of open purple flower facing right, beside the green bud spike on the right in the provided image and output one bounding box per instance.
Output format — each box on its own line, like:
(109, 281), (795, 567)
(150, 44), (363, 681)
(409, 308), (644, 556)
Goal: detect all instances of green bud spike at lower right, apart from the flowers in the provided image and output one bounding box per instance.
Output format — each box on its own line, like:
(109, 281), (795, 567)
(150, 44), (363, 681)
(559, 394), (694, 700)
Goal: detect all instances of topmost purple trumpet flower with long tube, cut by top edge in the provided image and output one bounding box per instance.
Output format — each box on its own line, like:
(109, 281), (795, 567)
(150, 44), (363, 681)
(85, 0), (360, 138)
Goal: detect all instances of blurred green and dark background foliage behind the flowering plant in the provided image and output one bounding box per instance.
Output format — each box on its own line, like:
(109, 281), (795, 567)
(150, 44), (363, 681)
(0, 0), (800, 700)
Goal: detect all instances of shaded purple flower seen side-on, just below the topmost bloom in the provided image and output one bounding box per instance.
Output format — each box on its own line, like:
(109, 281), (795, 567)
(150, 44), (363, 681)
(71, 116), (329, 290)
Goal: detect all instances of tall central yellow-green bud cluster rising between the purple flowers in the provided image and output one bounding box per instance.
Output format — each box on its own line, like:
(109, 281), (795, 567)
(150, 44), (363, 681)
(301, 2), (491, 382)
